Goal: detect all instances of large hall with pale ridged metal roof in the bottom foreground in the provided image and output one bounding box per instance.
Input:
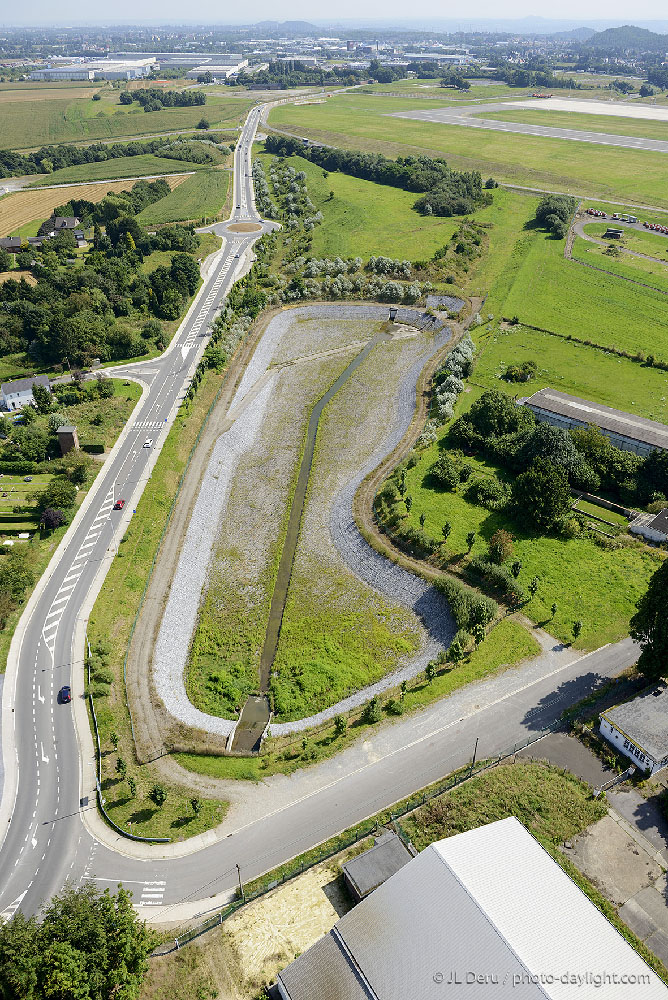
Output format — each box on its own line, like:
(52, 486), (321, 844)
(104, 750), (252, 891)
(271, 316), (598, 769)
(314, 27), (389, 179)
(277, 816), (668, 1000)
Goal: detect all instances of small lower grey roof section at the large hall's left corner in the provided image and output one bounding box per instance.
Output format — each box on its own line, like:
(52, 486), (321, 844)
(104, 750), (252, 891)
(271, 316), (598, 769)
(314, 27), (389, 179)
(279, 931), (376, 1000)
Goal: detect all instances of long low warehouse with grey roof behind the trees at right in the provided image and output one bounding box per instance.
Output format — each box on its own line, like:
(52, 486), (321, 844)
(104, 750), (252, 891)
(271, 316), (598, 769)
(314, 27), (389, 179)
(518, 388), (668, 455)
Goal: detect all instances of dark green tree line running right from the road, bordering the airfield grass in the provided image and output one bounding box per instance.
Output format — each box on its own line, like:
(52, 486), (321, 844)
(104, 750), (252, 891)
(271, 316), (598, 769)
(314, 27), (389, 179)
(265, 135), (494, 215)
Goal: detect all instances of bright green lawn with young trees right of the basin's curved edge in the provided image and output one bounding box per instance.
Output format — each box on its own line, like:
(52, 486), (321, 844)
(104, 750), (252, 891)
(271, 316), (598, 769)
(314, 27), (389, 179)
(406, 430), (661, 650)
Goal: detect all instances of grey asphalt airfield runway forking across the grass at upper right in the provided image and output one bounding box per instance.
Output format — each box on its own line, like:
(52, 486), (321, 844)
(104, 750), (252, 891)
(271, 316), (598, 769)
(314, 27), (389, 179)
(388, 102), (668, 153)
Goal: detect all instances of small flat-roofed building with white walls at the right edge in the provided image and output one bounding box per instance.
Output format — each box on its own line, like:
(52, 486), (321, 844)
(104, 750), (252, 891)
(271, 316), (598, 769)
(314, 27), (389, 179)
(599, 685), (668, 774)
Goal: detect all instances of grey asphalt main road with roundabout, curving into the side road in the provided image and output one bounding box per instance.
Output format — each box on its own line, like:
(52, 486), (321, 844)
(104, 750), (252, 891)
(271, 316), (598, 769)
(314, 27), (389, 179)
(0, 97), (637, 917)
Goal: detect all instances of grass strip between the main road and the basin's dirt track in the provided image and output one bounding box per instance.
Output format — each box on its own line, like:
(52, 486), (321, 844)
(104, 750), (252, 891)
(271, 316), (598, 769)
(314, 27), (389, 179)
(88, 372), (226, 839)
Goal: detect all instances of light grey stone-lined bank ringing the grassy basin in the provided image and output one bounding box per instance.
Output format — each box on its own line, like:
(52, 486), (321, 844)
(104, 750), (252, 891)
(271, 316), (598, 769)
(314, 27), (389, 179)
(153, 303), (456, 736)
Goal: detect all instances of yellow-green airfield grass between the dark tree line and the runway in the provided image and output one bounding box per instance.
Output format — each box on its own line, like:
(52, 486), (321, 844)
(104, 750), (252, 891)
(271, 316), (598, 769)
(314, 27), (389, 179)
(269, 93), (668, 207)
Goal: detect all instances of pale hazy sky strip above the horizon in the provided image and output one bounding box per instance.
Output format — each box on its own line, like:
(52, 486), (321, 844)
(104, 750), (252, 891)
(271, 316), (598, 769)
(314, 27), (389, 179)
(7, 0), (668, 24)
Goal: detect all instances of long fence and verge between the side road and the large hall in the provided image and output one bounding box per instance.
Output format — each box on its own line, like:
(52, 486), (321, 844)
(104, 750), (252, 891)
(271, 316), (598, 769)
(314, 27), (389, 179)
(151, 721), (563, 957)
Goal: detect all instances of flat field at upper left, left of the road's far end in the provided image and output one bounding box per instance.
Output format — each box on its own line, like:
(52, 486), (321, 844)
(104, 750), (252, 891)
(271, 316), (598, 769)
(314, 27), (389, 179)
(2, 90), (253, 150)
